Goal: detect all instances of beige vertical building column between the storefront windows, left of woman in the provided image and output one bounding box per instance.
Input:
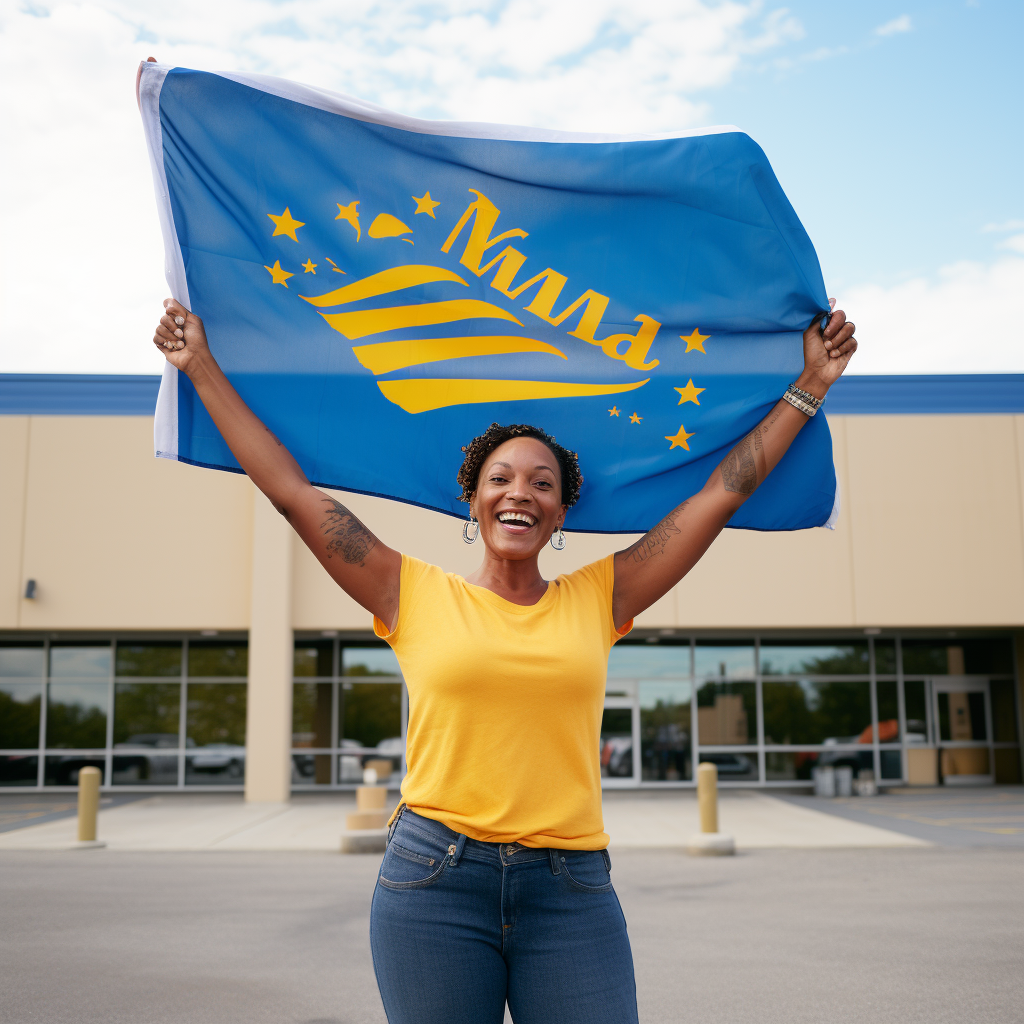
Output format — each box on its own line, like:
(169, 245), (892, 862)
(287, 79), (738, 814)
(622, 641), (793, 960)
(246, 487), (294, 803)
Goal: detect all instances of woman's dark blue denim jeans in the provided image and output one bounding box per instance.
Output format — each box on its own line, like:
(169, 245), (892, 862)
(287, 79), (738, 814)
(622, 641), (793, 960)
(370, 810), (637, 1024)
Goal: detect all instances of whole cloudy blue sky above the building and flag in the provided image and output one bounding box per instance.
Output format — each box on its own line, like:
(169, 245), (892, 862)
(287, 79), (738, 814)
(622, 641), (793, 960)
(0, 0), (1024, 374)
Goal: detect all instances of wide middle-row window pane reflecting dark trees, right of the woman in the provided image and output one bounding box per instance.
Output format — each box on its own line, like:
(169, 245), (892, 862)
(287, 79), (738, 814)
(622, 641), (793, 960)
(763, 679), (872, 745)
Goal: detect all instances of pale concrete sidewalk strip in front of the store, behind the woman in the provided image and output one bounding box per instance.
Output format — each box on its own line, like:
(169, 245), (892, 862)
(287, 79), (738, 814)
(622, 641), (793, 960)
(0, 790), (931, 853)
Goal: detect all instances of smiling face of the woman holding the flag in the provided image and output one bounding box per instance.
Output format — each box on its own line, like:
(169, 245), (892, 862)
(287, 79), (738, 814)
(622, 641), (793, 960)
(470, 437), (566, 559)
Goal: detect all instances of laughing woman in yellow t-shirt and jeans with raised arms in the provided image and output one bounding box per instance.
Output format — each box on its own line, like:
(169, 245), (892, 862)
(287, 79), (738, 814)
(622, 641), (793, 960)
(154, 299), (857, 1024)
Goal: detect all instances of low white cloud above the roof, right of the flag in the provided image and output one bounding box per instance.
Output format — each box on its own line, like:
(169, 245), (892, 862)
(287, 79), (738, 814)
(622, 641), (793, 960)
(840, 245), (1024, 374)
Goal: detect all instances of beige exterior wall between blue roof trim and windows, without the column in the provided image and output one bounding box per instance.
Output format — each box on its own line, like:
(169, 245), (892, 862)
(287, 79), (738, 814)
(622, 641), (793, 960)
(0, 407), (1024, 630)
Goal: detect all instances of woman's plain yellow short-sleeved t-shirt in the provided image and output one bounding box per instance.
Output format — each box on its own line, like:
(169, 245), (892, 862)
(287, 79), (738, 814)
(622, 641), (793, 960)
(374, 555), (633, 850)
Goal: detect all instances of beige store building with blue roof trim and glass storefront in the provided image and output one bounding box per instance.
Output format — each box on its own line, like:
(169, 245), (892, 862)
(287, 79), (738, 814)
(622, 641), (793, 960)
(0, 375), (1024, 800)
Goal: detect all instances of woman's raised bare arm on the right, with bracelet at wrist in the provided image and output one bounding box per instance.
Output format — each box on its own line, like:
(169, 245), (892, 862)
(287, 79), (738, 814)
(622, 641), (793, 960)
(612, 309), (857, 627)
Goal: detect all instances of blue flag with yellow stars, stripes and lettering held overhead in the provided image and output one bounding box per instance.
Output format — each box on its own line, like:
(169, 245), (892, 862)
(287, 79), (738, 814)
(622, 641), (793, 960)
(139, 63), (839, 532)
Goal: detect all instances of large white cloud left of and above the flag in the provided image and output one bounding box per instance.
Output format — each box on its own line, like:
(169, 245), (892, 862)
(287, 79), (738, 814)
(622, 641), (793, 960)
(0, 0), (802, 373)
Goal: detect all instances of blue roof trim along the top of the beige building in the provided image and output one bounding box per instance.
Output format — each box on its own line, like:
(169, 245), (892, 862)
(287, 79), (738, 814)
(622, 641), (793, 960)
(6, 374), (1024, 416)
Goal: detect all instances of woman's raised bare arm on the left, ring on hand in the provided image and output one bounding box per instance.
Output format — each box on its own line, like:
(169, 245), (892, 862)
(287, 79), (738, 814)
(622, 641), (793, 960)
(153, 299), (401, 629)
